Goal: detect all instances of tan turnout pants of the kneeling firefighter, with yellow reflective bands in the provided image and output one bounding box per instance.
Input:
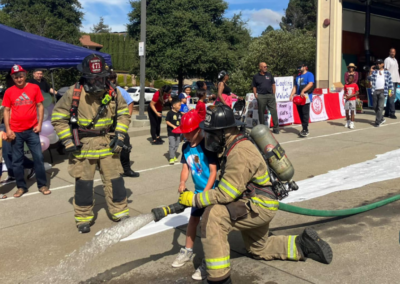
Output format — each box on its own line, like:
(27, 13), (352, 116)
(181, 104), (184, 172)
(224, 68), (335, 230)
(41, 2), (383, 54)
(201, 201), (302, 281)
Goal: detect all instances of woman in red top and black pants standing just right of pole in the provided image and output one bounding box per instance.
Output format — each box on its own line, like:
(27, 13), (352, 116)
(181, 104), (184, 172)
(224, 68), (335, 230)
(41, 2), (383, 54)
(147, 85), (172, 145)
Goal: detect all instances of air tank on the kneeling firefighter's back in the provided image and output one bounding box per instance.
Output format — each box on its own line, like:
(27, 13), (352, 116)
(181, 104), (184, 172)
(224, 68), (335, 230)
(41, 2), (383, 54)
(250, 125), (299, 200)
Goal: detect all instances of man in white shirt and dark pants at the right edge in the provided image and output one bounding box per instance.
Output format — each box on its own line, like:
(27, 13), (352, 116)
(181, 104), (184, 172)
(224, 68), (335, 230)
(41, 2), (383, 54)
(385, 48), (400, 119)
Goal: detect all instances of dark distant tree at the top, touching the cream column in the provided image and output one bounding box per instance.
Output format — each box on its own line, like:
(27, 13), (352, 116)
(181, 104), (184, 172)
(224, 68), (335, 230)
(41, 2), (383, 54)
(280, 0), (317, 33)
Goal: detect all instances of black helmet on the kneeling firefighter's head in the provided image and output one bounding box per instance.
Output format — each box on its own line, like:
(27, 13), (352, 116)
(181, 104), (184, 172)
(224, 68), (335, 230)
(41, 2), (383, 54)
(200, 105), (245, 131)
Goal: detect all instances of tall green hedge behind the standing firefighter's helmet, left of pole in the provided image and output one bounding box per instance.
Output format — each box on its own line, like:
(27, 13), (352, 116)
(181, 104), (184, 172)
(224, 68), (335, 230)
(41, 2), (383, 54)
(86, 33), (139, 72)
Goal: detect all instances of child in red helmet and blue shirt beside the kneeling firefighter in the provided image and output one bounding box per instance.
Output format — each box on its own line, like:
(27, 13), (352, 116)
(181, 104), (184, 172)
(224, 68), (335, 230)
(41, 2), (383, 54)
(172, 110), (218, 280)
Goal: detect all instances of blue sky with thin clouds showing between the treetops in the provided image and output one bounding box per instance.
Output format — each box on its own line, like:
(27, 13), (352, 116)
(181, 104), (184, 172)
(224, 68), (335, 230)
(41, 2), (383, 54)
(80, 0), (289, 36)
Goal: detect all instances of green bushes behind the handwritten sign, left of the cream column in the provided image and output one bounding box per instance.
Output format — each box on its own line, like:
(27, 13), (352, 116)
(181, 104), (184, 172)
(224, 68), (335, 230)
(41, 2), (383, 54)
(229, 30), (316, 96)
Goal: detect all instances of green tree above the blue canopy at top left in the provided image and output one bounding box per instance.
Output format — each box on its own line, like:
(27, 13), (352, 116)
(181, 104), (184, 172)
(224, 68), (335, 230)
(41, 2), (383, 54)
(0, 0), (83, 44)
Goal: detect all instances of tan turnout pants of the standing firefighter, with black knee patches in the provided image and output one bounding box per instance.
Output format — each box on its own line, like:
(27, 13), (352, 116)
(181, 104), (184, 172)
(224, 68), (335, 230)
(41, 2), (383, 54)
(68, 154), (129, 225)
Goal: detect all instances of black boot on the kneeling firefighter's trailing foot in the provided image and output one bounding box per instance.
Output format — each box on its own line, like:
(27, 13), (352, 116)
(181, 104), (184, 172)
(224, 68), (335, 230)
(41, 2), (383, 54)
(296, 228), (333, 264)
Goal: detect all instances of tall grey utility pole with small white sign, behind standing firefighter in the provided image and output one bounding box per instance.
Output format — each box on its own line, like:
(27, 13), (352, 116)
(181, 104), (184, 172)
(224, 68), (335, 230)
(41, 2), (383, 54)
(136, 0), (147, 120)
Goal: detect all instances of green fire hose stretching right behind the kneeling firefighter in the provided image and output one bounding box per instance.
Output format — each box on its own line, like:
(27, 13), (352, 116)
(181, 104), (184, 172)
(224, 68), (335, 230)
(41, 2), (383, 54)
(279, 195), (400, 217)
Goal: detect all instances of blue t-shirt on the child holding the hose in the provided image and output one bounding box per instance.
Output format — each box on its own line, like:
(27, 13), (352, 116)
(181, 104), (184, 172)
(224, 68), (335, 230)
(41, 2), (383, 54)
(181, 139), (218, 194)
